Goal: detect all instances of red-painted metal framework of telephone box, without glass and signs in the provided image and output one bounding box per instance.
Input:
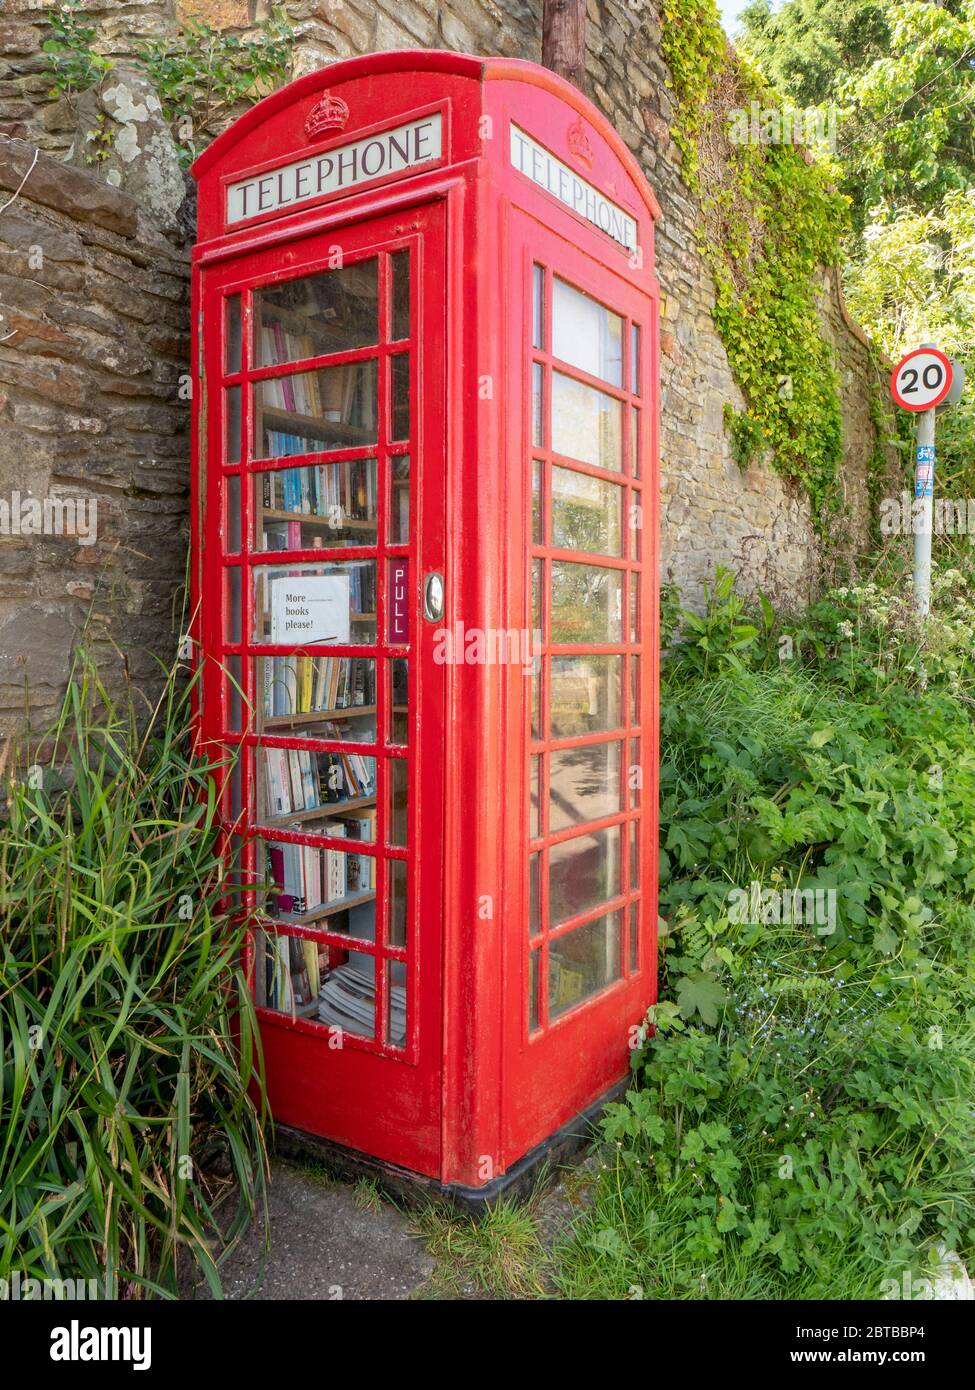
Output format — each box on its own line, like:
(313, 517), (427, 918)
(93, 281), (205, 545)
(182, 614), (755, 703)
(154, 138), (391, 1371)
(192, 51), (659, 1186)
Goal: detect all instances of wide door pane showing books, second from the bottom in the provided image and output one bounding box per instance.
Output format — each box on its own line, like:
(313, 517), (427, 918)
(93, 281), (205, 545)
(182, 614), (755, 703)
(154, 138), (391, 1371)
(257, 840), (376, 922)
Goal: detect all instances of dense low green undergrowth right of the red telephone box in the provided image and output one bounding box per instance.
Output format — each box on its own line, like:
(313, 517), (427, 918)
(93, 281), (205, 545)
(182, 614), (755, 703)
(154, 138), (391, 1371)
(556, 558), (975, 1298)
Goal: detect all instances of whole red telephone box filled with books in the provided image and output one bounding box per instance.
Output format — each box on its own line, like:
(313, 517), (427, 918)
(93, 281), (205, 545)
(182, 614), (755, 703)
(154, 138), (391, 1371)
(193, 51), (658, 1197)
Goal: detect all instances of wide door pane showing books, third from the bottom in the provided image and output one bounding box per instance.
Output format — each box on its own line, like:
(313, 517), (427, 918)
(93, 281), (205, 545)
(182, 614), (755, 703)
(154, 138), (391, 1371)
(259, 756), (376, 840)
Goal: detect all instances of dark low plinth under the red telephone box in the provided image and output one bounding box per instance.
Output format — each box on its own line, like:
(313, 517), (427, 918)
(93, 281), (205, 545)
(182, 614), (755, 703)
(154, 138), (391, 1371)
(274, 1080), (630, 1220)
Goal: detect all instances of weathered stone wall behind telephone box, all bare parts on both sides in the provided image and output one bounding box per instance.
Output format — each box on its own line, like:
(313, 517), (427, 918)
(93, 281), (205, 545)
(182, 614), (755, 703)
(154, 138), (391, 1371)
(0, 0), (895, 739)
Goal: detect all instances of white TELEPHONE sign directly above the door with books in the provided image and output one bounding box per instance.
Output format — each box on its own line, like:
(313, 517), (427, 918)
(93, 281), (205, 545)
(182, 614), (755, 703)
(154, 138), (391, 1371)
(227, 113), (442, 224)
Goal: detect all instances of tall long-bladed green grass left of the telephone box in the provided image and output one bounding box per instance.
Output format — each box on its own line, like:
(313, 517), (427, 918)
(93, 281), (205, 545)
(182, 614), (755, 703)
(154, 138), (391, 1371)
(0, 644), (266, 1298)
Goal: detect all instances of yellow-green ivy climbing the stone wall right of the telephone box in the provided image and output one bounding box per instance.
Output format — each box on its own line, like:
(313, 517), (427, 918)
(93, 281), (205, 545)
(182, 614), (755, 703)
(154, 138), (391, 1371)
(661, 0), (846, 532)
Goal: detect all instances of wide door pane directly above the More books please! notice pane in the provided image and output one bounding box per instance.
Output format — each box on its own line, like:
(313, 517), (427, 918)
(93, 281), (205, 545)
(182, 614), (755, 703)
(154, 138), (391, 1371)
(255, 459), (377, 550)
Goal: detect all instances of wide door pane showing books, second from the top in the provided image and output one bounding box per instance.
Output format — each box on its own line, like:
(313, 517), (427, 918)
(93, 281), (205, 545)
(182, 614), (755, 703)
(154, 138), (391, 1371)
(253, 361), (377, 459)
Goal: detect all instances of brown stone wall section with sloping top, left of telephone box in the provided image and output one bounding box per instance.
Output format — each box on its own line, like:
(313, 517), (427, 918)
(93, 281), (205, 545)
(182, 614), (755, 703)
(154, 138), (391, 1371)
(0, 136), (189, 731)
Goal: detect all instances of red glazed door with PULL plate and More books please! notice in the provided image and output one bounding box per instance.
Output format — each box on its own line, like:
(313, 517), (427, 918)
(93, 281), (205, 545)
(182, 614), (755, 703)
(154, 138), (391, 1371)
(200, 203), (445, 1175)
